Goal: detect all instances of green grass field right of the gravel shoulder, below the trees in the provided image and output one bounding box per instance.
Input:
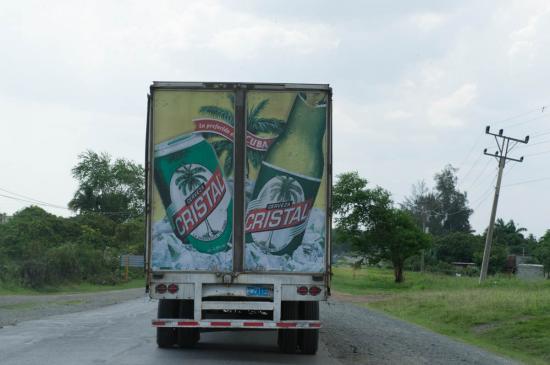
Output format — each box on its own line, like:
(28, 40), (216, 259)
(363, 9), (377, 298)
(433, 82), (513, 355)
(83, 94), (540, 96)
(333, 267), (550, 364)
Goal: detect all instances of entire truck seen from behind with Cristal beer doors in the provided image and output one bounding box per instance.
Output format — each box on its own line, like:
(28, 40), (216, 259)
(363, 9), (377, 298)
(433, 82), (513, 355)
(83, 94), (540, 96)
(145, 82), (332, 354)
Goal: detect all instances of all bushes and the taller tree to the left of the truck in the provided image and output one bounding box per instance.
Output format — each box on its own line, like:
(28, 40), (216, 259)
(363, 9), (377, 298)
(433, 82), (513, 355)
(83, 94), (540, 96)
(0, 151), (145, 288)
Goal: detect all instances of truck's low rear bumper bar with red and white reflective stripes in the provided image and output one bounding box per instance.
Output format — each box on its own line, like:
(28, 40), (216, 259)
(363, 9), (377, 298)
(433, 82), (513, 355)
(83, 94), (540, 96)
(152, 318), (321, 329)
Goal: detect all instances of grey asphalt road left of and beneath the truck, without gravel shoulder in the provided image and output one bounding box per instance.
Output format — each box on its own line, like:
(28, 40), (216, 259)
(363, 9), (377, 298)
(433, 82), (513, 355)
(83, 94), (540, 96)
(0, 299), (339, 365)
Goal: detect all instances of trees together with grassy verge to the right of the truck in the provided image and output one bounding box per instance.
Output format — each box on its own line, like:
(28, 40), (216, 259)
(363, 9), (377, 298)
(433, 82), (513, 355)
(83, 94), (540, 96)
(333, 165), (550, 364)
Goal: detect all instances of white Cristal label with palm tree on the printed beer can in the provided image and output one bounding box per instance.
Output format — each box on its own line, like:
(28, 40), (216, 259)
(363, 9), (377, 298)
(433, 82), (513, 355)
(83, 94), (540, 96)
(167, 164), (228, 241)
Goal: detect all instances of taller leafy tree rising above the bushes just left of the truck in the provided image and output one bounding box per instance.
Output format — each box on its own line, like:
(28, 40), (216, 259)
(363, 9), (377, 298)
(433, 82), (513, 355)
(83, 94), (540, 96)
(69, 150), (145, 222)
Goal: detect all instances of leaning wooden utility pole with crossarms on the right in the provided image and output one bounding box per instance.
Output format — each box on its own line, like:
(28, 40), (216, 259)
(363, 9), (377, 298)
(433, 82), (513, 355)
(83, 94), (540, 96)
(479, 126), (529, 284)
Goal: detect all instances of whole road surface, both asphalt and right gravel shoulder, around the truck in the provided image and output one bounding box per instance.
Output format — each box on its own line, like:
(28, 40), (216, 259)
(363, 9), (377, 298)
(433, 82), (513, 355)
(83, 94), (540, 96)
(0, 298), (515, 365)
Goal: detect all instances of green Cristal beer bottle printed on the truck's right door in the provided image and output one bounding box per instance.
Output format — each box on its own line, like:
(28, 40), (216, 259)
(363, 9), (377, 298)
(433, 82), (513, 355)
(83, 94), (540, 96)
(245, 92), (327, 255)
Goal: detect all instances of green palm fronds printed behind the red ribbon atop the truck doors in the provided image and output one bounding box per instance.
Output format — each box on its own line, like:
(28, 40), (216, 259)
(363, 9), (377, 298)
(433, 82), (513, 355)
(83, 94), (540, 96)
(199, 94), (284, 178)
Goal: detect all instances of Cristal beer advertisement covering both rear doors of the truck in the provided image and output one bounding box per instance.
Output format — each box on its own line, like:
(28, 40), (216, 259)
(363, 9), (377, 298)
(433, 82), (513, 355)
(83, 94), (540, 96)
(151, 86), (327, 272)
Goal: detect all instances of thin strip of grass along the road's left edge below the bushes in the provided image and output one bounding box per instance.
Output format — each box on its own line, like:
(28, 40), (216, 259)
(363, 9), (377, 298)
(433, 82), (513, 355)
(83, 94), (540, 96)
(0, 278), (145, 295)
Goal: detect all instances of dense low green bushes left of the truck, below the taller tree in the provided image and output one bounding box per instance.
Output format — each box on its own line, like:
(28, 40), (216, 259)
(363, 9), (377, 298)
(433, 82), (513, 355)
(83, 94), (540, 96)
(0, 207), (145, 289)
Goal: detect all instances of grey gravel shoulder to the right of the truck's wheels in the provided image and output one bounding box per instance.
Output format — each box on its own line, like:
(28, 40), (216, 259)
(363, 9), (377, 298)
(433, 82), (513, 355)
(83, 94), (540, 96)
(321, 300), (518, 365)
